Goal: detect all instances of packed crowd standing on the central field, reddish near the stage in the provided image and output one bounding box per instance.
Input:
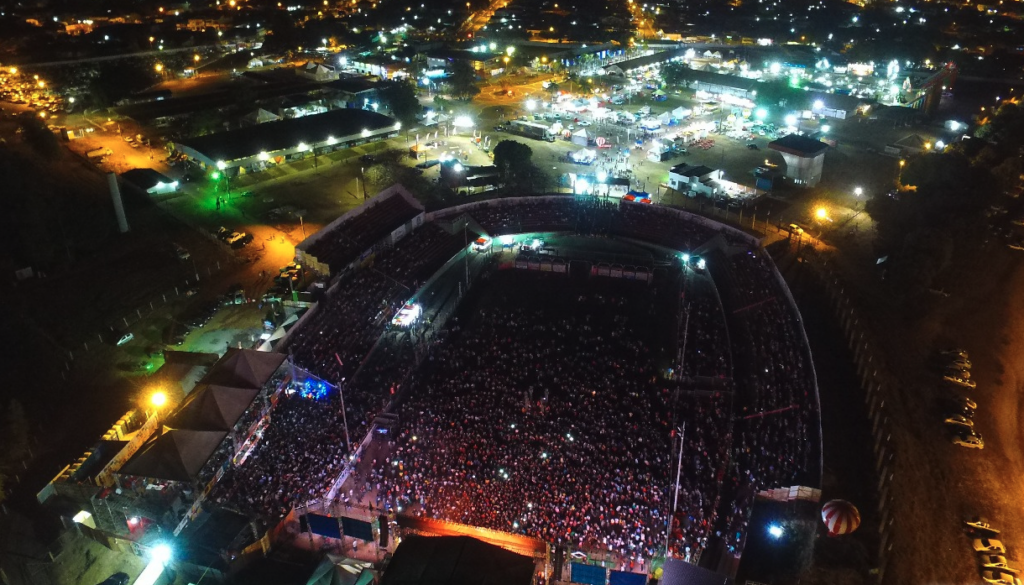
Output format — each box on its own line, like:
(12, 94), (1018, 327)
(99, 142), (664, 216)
(368, 275), (725, 559)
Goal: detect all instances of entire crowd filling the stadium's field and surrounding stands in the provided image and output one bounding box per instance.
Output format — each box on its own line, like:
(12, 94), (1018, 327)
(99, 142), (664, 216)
(205, 198), (817, 560)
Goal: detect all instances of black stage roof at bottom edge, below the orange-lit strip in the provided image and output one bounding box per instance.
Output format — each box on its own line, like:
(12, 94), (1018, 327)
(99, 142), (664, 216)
(380, 535), (534, 585)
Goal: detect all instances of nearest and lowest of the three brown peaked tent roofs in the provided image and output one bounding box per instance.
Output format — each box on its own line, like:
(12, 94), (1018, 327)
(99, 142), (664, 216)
(120, 429), (227, 482)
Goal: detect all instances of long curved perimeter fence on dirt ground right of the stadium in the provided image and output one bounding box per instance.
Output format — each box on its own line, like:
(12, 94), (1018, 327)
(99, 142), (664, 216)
(808, 254), (896, 583)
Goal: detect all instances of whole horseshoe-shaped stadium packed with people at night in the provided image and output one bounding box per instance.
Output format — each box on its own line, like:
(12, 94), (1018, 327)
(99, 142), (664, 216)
(204, 185), (821, 582)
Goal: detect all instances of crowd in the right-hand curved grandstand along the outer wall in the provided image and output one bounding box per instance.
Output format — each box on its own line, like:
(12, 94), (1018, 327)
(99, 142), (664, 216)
(720, 250), (820, 549)
